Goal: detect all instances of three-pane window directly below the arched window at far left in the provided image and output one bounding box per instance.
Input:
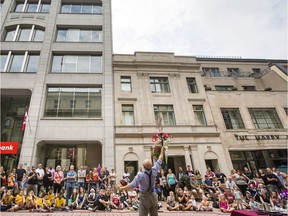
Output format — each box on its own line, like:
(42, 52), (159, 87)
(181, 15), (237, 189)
(1, 51), (39, 73)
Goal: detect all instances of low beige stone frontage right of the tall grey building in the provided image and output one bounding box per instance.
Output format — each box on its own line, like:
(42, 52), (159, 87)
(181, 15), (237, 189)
(113, 52), (287, 177)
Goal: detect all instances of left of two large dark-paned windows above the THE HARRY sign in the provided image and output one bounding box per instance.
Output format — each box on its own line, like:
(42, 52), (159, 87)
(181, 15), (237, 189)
(221, 108), (245, 129)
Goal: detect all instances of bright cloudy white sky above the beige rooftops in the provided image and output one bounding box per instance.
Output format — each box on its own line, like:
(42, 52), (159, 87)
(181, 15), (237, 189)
(111, 0), (288, 59)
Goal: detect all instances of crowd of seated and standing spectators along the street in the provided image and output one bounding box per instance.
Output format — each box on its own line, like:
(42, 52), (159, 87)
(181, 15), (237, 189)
(0, 164), (288, 212)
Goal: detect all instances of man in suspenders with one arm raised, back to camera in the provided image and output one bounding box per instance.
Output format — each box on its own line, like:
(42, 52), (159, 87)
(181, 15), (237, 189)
(117, 146), (165, 216)
